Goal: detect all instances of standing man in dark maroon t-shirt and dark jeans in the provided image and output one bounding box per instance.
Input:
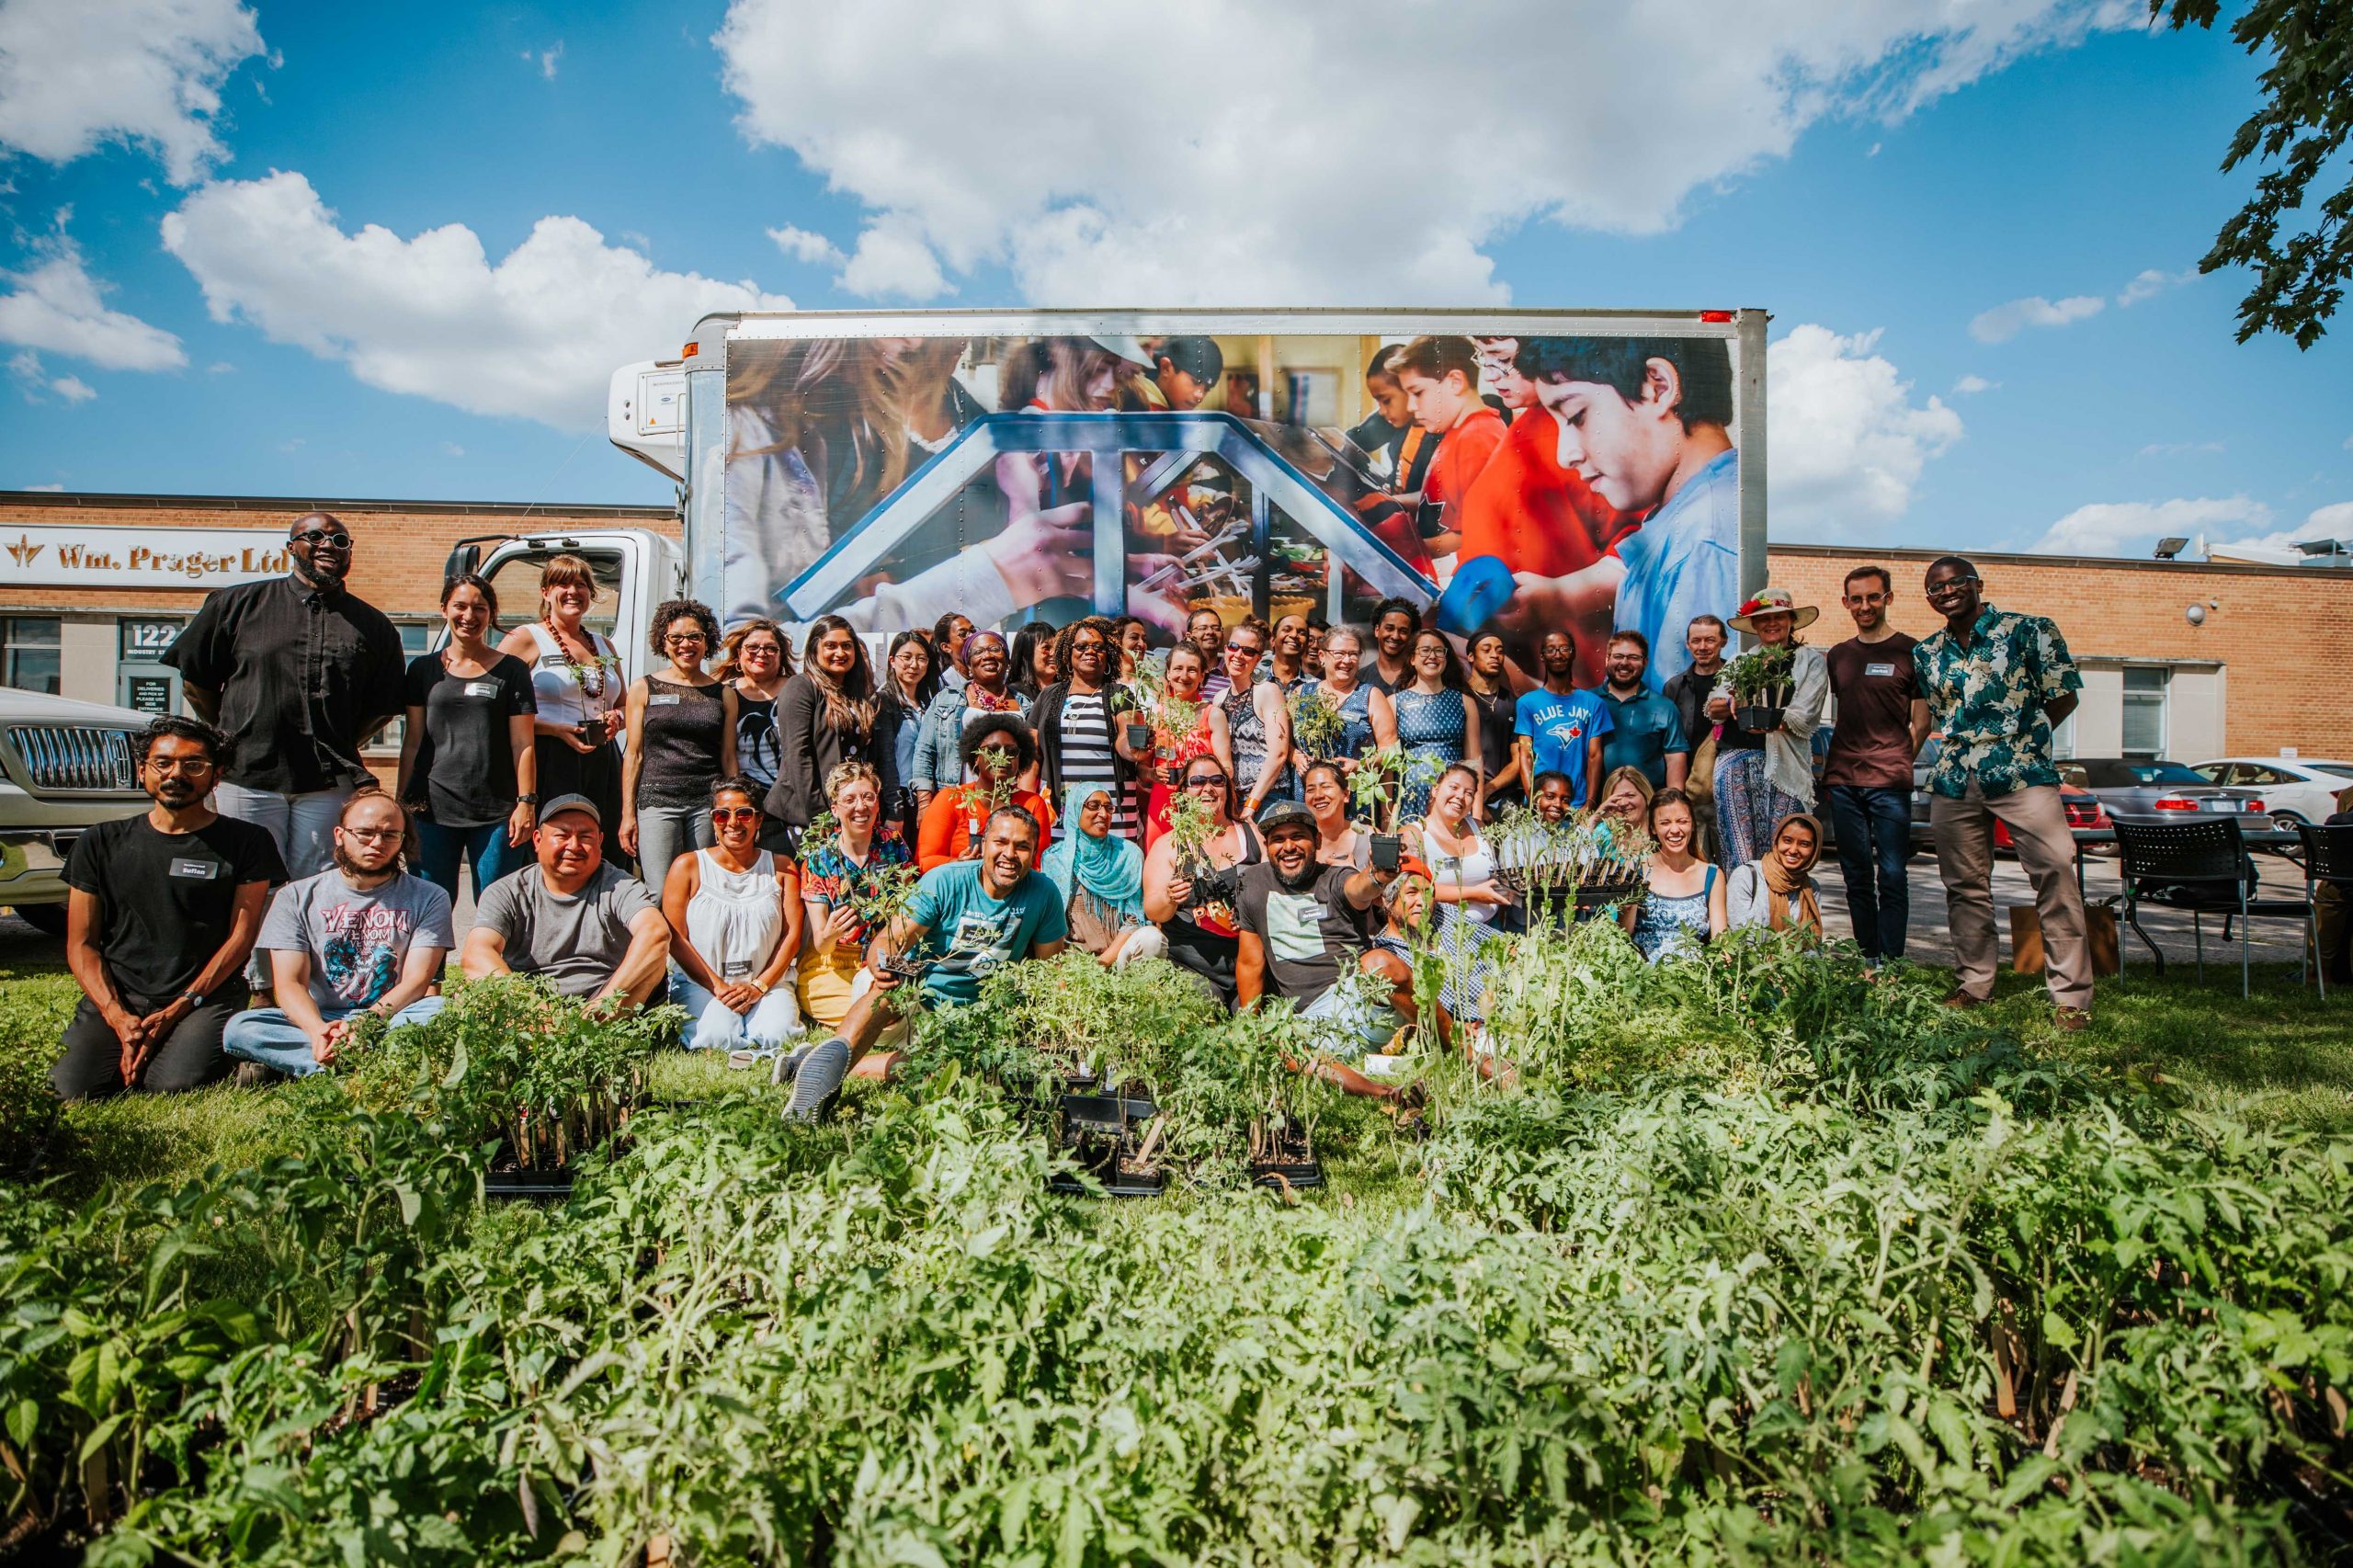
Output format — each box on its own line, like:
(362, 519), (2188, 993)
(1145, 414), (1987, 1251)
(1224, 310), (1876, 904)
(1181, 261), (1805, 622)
(1821, 565), (1927, 963)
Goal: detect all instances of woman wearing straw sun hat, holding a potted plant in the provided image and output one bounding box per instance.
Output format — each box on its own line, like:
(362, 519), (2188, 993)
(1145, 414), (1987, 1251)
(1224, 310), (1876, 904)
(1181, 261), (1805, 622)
(1709, 588), (1831, 871)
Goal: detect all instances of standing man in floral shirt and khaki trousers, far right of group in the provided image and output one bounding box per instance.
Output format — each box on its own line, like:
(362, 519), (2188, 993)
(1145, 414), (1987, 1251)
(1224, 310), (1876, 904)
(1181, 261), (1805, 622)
(1913, 556), (2092, 1028)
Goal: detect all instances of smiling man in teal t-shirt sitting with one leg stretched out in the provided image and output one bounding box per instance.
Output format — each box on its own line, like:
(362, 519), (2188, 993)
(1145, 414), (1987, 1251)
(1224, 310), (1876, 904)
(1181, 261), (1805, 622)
(777, 805), (1068, 1120)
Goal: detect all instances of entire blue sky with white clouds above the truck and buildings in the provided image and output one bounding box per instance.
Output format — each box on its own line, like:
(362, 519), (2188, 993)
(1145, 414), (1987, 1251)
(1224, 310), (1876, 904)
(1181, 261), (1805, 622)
(0, 0), (2353, 553)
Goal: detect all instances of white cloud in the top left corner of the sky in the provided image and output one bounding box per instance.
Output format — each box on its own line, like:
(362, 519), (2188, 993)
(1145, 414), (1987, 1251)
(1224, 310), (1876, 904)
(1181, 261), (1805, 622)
(0, 0), (261, 186)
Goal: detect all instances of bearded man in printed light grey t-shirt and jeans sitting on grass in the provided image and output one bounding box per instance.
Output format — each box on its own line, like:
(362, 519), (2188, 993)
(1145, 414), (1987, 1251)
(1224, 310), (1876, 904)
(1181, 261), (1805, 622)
(222, 789), (457, 1083)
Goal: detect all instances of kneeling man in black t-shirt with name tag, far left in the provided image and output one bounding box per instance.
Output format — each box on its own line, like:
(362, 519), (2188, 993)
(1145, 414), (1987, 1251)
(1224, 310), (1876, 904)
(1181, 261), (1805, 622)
(50, 718), (287, 1099)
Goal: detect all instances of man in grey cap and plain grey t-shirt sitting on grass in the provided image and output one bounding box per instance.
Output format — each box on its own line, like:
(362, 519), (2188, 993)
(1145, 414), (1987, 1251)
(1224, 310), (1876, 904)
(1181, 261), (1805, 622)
(463, 796), (671, 1007)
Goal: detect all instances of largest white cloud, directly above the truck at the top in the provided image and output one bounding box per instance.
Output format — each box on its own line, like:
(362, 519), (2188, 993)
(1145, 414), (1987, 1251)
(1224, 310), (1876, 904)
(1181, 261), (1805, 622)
(715, 0), (2134, 303)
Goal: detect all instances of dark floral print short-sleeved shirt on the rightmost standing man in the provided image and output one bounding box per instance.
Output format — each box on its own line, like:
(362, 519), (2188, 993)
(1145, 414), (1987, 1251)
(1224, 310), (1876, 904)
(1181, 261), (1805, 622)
(1913, 605), (2083, 801)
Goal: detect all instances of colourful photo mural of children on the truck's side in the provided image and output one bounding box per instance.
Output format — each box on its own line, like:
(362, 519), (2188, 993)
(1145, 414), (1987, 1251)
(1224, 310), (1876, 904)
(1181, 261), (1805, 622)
(722, 322), (1739, 690)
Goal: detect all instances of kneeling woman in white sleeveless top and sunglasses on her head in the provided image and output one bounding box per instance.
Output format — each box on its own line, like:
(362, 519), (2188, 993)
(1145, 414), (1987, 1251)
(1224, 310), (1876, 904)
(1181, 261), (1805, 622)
(661, 779), (802, 1066)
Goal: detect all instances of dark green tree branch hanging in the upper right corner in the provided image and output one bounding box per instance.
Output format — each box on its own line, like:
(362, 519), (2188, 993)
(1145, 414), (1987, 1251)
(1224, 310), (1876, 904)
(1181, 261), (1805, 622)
(2148, 0), (2353, 348)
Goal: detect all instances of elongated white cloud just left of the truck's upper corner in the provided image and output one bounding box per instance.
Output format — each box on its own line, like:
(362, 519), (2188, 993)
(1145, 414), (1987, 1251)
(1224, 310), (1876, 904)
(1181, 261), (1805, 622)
(163, 172), (793, 431)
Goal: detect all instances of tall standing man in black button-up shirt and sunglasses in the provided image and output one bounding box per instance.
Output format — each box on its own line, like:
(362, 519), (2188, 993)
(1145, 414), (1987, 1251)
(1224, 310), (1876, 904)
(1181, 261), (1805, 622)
(163, 511), (407, 876)
